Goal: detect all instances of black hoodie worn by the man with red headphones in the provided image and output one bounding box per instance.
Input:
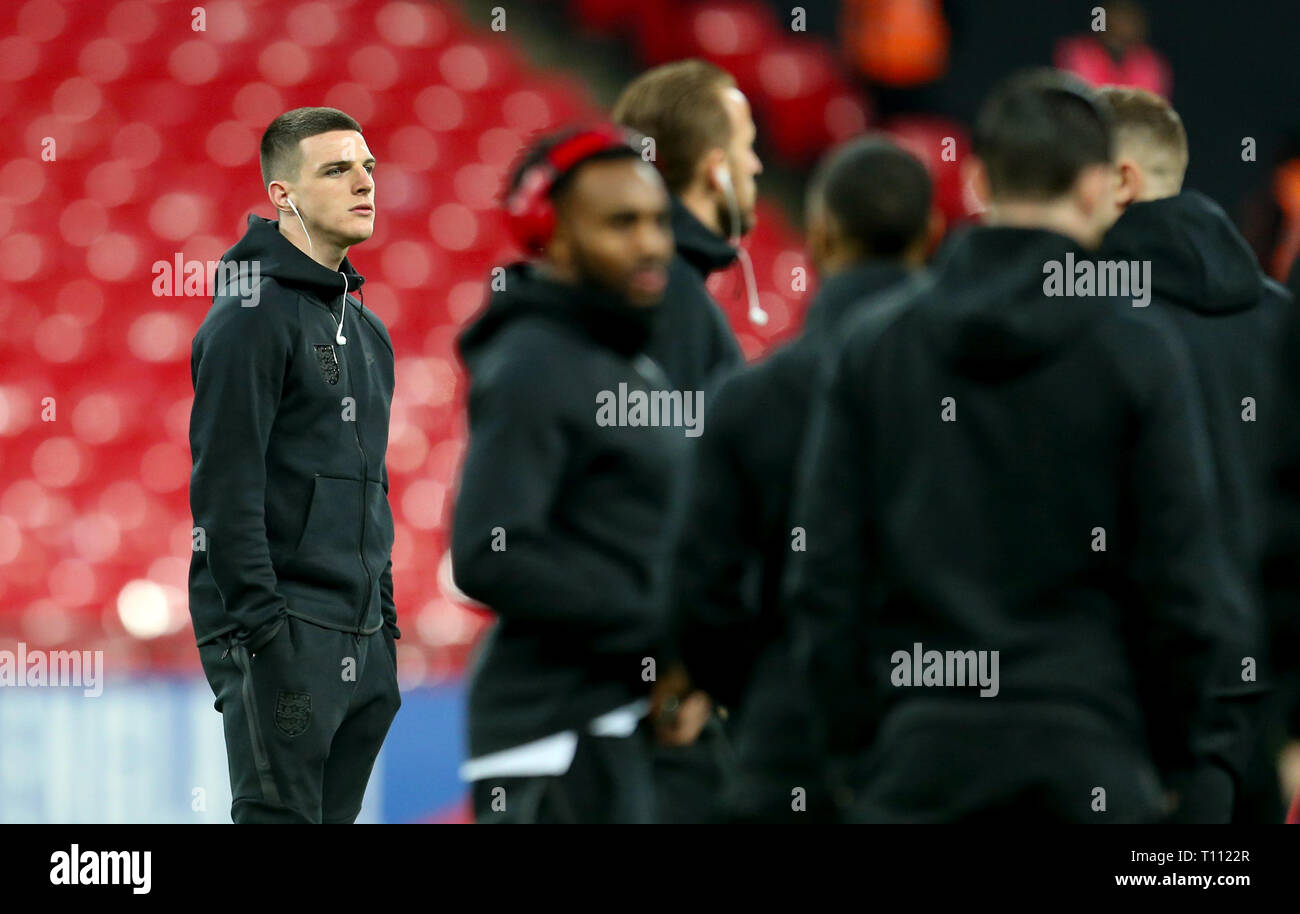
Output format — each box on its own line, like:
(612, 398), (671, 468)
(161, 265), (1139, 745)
(451, 264), (688, 757)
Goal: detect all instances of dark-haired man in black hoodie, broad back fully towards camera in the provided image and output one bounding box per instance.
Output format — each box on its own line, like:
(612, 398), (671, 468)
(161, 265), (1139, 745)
(789, 73), (1231, 822)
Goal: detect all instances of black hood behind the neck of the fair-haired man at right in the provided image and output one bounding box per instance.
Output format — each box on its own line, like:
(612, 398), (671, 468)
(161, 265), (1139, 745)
(1101, 191), (1264, 313)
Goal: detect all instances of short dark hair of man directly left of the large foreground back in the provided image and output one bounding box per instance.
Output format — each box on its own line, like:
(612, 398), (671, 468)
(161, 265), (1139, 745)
(807, 135), (933, 257)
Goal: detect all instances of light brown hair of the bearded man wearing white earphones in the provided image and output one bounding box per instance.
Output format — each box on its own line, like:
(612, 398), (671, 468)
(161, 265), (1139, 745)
(614, 60), (736, 194)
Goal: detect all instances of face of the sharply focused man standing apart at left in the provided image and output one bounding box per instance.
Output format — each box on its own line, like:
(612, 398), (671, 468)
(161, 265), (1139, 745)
(286, 130), (374, 248)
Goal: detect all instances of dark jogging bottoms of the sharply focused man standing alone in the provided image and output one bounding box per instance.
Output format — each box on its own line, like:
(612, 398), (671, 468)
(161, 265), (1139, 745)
(199, 616), (402, 824)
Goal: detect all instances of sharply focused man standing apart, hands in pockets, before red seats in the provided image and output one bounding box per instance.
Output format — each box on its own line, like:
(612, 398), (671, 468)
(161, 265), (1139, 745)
(190, 108), (402, 823)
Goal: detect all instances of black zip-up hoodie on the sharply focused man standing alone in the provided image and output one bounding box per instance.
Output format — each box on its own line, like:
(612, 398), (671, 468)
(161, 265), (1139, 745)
(190, 216), (399, 650)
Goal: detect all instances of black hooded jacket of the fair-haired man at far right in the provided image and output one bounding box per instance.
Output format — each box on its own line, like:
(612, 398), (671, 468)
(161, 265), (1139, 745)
(1100, 191), (1295, 759)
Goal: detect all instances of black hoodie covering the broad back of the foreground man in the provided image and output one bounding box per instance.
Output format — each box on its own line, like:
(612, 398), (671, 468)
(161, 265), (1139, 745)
(789, 228), (1232, 816)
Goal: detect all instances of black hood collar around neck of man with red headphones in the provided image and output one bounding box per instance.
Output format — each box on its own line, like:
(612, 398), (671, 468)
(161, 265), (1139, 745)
(459, 263), (659, 359)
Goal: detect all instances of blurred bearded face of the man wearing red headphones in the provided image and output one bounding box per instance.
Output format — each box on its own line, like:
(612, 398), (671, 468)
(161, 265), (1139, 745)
(549, 159), (673, 307)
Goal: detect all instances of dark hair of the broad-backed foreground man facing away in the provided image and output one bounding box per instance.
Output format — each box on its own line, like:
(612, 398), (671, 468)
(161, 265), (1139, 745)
(972, 69), (1113, 200)
